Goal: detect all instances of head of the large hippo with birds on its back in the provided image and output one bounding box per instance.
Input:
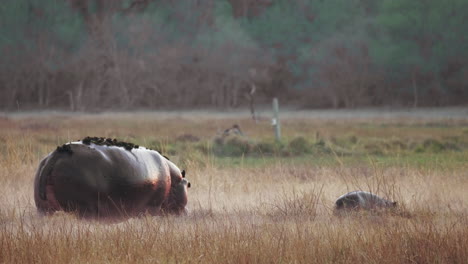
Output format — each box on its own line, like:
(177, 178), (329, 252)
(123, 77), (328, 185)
(162, 170), (191, 214)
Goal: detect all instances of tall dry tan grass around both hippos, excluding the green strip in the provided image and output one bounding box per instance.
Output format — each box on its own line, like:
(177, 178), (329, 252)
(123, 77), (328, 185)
(0, 112), (468, 263)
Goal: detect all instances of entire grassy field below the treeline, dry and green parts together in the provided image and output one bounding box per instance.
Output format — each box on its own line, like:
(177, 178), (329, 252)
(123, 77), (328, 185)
(0, 110), (468, 263)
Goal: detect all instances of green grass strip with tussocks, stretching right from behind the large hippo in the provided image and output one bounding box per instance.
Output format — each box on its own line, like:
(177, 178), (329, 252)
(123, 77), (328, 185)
(127, 134), (468, 168)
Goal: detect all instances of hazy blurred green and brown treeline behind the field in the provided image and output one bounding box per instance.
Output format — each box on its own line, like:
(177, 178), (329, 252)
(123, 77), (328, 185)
(0, 0), (468, 111)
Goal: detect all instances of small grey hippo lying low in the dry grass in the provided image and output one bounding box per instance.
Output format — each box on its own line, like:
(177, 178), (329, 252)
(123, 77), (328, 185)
(335, 191), (397, 211)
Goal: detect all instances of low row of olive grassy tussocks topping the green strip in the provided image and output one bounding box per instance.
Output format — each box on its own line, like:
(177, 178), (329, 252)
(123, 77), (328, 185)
(176, 135), (468, 157)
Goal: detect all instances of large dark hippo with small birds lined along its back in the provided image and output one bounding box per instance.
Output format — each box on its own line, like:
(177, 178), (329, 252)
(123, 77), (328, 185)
(34, 137), (190, 218)
